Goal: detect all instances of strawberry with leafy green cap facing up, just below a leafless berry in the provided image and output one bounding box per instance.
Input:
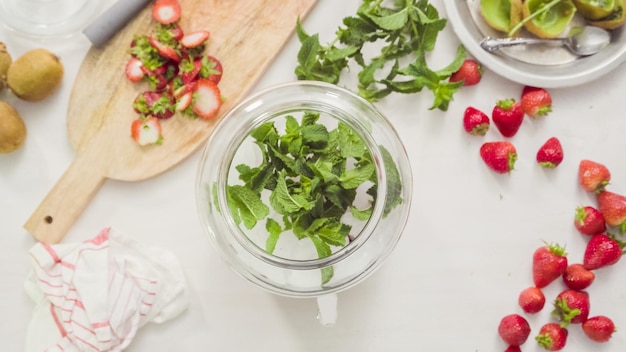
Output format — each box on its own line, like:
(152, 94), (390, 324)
(552, 289), (589, 327)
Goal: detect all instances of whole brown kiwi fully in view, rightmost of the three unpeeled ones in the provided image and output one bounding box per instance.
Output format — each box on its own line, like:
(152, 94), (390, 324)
(7, 48), (63, 101)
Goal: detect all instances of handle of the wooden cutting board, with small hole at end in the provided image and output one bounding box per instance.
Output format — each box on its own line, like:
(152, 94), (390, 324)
(24, 154), (106, 244)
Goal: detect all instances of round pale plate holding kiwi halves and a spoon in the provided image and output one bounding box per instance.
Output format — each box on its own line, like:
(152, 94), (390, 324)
(444, 0), (626, 88)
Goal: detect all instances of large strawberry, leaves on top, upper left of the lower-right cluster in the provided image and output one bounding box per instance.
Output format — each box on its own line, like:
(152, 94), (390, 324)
(532, 244), (567, 288)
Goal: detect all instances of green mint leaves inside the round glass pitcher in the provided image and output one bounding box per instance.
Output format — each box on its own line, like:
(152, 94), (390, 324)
(227, 112), (402, 284)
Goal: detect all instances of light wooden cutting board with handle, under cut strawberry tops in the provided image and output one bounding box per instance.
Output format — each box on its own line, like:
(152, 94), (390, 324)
(24, 0), (317, 243)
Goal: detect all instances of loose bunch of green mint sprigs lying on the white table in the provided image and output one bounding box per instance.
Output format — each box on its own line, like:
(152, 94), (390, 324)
(295, 0), (466, 111)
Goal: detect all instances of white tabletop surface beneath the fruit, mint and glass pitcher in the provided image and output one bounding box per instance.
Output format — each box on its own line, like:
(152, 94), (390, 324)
(0, 0), (626, 352)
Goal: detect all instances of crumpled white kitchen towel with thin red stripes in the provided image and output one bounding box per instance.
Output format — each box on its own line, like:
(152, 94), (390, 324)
(25, 228), (188, 352)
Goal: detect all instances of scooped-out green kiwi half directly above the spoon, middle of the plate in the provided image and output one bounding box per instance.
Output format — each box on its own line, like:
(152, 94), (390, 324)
(522, 0), (576, 38)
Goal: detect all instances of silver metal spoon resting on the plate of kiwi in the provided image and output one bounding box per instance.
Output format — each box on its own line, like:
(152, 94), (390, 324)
(480, 26), (611, 56)
